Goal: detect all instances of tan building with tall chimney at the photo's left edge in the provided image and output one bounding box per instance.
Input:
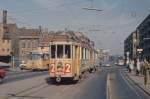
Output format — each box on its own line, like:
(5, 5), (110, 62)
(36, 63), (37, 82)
(0, 10), (17, 63)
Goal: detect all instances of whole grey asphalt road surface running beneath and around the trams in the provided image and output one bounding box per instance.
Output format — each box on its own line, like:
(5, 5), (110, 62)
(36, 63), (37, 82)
(0, 63), (150, 99)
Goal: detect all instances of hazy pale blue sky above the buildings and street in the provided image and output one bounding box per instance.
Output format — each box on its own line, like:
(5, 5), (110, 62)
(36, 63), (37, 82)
(0, 0), (150, 54)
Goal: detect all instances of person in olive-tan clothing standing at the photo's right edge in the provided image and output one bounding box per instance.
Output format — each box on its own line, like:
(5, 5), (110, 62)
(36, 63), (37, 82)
(144, 59), (150, 85)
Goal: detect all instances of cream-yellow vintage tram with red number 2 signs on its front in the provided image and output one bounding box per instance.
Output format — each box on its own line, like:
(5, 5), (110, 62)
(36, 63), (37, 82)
(49, 32), (97, 82)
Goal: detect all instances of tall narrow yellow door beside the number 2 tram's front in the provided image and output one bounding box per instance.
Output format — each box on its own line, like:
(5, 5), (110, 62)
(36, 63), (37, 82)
(75, 45), (80, 77)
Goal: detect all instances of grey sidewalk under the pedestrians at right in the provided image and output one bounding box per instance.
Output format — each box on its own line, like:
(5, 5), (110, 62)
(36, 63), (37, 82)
(125, 71), (150, 95)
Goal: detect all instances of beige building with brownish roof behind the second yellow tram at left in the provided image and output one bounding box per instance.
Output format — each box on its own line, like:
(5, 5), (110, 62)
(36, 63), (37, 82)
(17, 28), (39, 59)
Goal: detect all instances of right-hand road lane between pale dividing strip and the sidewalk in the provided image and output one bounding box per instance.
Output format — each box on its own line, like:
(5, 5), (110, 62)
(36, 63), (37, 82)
(108, 67), (150, 99)
